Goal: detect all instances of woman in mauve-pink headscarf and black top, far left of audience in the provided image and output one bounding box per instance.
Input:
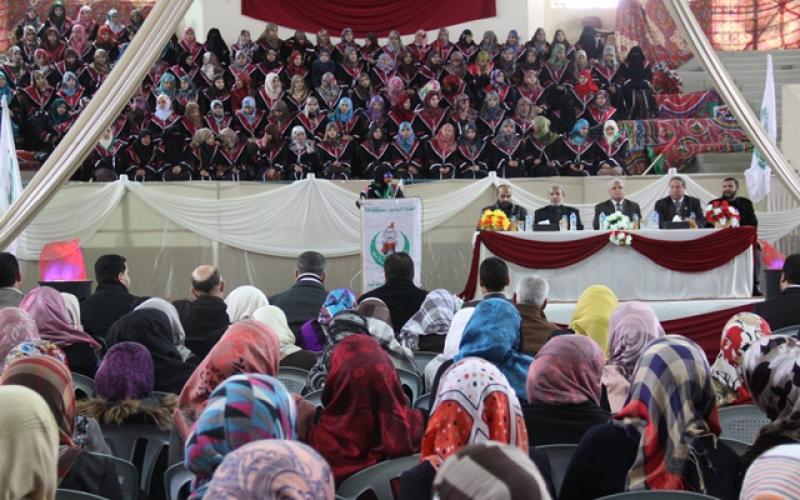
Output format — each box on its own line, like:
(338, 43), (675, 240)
(20, 286), (100, 378)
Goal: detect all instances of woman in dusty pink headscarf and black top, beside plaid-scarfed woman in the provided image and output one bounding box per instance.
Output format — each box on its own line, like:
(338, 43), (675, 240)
(523, 335), (611, 447)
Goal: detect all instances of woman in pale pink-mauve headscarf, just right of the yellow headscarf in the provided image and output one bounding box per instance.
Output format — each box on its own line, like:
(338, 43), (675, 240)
(601, 301), (664, 413)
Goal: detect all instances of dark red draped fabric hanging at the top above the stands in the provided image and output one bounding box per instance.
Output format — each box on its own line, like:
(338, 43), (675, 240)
(242, 0), (497, 36)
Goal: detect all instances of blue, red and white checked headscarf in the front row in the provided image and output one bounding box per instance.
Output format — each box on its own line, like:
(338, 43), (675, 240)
(185, 373), (297, 499)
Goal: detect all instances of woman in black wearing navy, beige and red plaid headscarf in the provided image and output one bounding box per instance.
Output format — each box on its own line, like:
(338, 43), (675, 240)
(559, 335), (739, 500)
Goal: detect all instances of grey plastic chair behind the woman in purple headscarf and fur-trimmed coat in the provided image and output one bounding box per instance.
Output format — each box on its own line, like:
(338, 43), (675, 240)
(100, 424), (169, 492)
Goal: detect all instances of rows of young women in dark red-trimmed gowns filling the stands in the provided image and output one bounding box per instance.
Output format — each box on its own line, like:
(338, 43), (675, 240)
(6, 3), (656, 181)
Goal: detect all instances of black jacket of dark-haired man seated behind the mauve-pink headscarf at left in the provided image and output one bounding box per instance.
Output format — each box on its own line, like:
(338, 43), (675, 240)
(81, 282), (139, 338)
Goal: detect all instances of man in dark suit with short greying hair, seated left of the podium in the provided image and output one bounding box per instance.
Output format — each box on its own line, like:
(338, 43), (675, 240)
(269, 251), (328, 338)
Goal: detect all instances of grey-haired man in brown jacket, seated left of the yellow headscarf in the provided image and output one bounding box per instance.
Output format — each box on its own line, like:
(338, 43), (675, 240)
(514, 275), (559, 354)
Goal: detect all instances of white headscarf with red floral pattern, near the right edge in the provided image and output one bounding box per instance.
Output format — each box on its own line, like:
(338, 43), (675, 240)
(711, 313), (772, 406)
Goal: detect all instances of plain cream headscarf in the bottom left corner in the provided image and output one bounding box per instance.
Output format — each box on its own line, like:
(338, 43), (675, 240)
(0, 386), (59, 499)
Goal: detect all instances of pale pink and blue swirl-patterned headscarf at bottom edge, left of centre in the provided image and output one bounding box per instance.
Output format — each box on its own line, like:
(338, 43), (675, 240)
(206, 439), (336, 500)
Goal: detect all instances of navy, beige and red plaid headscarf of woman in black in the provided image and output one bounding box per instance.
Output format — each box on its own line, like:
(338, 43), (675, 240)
(614, 335), (720, 493)
